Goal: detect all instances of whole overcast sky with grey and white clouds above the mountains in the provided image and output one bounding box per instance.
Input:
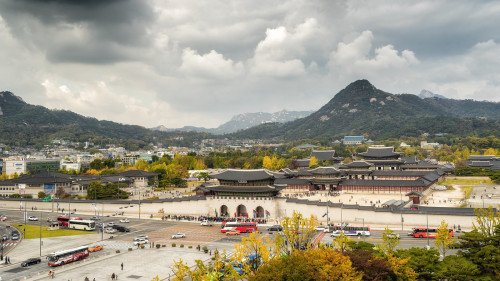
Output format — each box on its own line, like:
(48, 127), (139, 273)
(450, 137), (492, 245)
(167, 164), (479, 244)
(0, 0), (500, 128)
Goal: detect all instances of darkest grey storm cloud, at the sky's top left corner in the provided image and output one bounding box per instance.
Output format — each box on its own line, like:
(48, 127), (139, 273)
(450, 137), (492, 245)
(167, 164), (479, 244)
(0, 0), (155, 64)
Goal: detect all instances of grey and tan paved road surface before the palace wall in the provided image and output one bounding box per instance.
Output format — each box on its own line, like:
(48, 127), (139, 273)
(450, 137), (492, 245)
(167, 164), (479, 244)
(0, 207), (466, 280)
